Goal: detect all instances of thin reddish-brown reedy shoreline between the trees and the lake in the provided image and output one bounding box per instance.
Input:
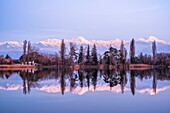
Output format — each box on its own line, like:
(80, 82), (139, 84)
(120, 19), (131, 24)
(0, 64), (170, 70)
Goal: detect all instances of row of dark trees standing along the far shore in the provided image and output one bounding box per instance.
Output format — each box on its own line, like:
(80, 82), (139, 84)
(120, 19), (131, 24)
(0, 39), (170, 68)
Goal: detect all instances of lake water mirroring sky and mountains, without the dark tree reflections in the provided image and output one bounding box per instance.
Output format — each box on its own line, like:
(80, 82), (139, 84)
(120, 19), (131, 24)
(0, 69), (170, 113)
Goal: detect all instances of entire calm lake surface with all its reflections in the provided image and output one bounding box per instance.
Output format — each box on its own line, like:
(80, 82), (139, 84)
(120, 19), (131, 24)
(0, 70), (170, 113)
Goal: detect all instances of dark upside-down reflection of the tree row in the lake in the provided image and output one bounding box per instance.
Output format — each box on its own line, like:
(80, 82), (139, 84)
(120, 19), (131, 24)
(0, 69), (170, 95)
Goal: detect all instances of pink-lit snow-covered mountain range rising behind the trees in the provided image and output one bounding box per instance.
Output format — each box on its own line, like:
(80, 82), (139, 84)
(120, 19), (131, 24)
(0, 36), (170, 59)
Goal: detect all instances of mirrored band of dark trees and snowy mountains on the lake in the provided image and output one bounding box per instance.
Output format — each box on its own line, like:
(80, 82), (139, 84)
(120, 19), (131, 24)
(0, 69), (170, 95)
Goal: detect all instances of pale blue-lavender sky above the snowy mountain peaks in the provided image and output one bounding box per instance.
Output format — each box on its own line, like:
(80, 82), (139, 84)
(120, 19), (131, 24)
(0, 0), (170, 42)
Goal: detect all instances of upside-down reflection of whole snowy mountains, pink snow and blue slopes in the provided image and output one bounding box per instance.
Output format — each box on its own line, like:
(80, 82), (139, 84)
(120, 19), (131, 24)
(0, 75), (170, 95)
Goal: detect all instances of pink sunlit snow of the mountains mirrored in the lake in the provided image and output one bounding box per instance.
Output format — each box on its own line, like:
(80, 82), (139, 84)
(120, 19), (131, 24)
(0, 84), (170, 95)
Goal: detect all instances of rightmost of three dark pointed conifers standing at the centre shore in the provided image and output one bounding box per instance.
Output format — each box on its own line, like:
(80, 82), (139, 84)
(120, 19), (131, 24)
(91, 44), (98, 65)
